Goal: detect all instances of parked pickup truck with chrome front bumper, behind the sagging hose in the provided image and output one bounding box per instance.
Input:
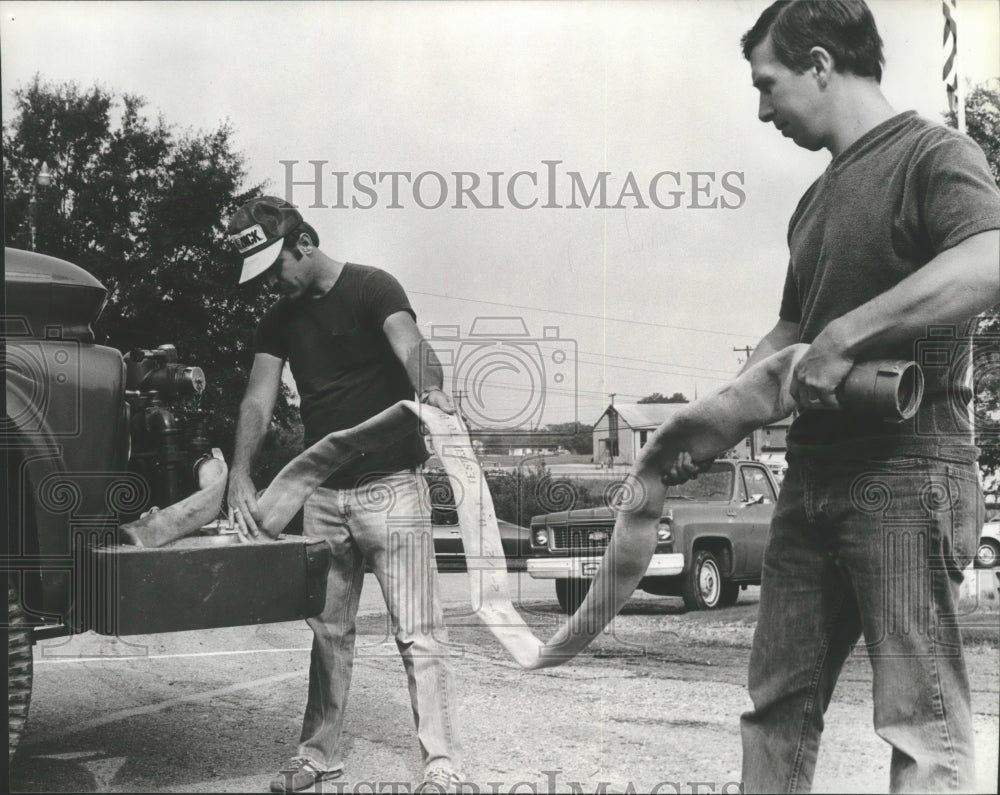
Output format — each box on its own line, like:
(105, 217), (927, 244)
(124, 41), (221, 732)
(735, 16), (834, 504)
(527, 459), (778, 613)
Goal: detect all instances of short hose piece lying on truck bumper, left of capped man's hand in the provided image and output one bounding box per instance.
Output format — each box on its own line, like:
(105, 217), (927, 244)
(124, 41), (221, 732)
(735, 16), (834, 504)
(120, 449), (229, 547)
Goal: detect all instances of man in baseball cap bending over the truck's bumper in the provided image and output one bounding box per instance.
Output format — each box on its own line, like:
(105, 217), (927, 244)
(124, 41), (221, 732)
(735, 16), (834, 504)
(228, 196), (461, 792)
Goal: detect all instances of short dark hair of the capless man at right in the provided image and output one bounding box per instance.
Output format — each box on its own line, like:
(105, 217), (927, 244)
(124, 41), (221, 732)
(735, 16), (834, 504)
(740, 0), (885, 83)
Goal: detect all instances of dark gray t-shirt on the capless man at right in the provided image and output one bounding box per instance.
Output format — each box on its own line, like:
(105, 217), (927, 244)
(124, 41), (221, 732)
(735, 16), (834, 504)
(780, 111), (1000, 458)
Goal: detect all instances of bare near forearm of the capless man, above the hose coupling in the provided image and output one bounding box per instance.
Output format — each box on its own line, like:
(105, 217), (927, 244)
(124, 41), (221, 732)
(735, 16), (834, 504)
(817, 231), (1000, 361)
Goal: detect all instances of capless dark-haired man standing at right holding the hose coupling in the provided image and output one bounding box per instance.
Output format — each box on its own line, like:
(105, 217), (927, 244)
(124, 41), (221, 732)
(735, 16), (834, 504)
(688, 0), (1000, 792)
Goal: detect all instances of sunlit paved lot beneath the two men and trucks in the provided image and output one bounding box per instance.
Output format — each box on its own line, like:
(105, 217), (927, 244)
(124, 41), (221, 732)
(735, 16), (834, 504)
(10, 574), (1000, 793)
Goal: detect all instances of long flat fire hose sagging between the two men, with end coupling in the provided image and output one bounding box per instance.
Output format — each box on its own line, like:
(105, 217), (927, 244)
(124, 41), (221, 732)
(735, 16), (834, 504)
(258, 345), (923, 669)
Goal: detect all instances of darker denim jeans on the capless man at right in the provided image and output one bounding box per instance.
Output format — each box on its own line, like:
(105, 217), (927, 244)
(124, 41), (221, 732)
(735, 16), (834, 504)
(740, 456), (984, 792)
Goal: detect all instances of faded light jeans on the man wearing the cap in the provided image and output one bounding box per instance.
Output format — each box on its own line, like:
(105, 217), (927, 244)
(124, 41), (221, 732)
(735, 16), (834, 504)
(298, 470), (459, 770)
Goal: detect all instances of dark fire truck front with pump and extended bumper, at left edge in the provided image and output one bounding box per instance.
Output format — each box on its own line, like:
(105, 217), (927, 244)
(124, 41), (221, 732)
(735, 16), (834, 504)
(0, 248), (332, 757)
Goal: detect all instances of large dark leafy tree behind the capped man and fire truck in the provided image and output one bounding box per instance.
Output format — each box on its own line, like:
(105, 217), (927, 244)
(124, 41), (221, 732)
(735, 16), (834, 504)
(3, 75), (297, 460)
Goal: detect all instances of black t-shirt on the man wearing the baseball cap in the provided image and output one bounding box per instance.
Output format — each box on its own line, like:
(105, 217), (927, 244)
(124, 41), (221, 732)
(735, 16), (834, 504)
(254, 262), (427, 488)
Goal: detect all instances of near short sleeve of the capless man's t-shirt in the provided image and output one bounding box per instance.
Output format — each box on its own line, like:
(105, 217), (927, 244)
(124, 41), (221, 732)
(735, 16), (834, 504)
(902, 130), (1000, 256)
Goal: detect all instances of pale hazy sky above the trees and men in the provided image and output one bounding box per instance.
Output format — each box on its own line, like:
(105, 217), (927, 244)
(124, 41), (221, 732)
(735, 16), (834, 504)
(0, 0), (1000, 436)
